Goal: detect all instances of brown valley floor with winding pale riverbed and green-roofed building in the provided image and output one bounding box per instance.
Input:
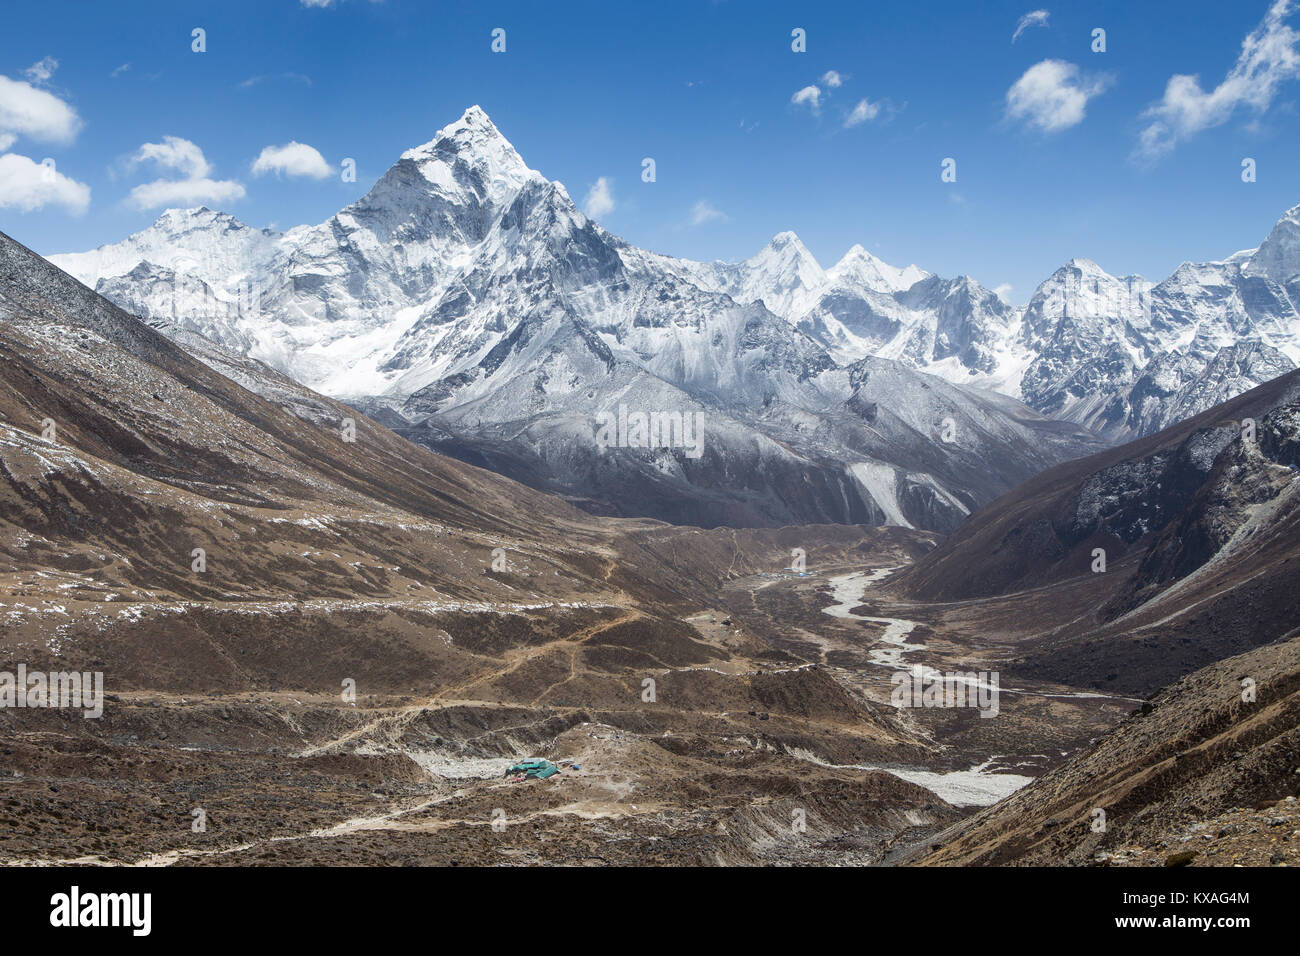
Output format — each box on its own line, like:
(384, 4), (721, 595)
(0, 530), (1159, 865)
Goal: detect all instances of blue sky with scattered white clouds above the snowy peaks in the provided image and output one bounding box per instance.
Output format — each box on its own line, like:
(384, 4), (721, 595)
(0, 0), (1300, 302)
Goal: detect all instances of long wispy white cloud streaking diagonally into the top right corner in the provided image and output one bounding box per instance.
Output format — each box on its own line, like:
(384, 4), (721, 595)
(1136, 0), (1300, 160)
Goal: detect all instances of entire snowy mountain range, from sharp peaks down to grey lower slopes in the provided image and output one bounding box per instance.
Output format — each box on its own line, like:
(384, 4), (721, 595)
(51, 107), (1300, 532)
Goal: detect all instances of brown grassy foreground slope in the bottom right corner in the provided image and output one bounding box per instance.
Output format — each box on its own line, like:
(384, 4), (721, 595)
(918, 631), (1300, 865)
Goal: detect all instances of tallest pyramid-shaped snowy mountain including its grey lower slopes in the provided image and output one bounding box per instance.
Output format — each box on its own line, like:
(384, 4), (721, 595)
(45, 108), (1100, 531)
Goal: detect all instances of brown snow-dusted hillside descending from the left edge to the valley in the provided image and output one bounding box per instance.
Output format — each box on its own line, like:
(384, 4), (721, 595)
(0, 223), (681, 624)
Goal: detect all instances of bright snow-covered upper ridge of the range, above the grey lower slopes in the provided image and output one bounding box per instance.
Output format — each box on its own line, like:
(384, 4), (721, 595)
(52, 107), (1300, 455)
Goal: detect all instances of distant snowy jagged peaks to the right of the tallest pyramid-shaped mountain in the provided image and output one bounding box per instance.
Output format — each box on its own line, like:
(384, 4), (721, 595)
(660, 207), (1300, 441)
